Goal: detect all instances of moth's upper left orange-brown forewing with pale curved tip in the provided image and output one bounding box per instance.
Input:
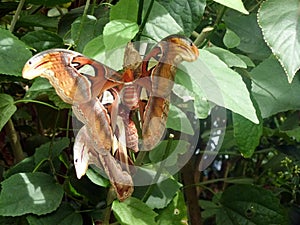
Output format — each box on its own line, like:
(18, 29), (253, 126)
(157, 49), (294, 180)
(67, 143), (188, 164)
(22, 49), (122, 104)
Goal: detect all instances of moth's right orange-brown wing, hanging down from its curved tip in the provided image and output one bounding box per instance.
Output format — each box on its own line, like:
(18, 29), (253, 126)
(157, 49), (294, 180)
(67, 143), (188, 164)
(142, 35), (199, 150)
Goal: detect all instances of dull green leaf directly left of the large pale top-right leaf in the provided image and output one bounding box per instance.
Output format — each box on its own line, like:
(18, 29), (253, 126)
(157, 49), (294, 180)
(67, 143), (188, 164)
(223, 10), (271, 59)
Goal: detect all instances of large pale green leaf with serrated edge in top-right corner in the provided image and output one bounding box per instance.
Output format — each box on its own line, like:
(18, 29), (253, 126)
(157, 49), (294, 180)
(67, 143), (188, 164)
(258, 0), (300, 82)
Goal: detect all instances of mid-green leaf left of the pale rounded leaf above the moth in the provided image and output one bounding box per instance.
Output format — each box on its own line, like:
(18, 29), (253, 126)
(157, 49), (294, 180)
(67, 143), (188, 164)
(71, 15), (97, 52)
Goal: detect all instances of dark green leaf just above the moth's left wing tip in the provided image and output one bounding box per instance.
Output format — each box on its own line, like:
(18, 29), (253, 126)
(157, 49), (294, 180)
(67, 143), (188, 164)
(21, 30), (64, 52)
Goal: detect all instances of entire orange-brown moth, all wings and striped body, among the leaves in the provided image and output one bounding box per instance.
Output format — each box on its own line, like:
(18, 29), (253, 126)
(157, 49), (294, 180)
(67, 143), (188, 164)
(23, 35), (198, 200)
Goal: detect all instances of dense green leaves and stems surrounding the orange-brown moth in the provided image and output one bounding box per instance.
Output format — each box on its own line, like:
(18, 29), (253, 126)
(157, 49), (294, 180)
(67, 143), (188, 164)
(0, 0), (300, 225)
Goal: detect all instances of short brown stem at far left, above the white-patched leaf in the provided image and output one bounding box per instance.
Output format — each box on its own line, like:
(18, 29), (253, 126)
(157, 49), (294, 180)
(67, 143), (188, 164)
(4, 119), (24, 163)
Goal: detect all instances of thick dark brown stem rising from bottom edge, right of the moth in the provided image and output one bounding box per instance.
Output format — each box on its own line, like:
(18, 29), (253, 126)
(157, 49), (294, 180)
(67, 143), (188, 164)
(182, 160), (203, 225)
